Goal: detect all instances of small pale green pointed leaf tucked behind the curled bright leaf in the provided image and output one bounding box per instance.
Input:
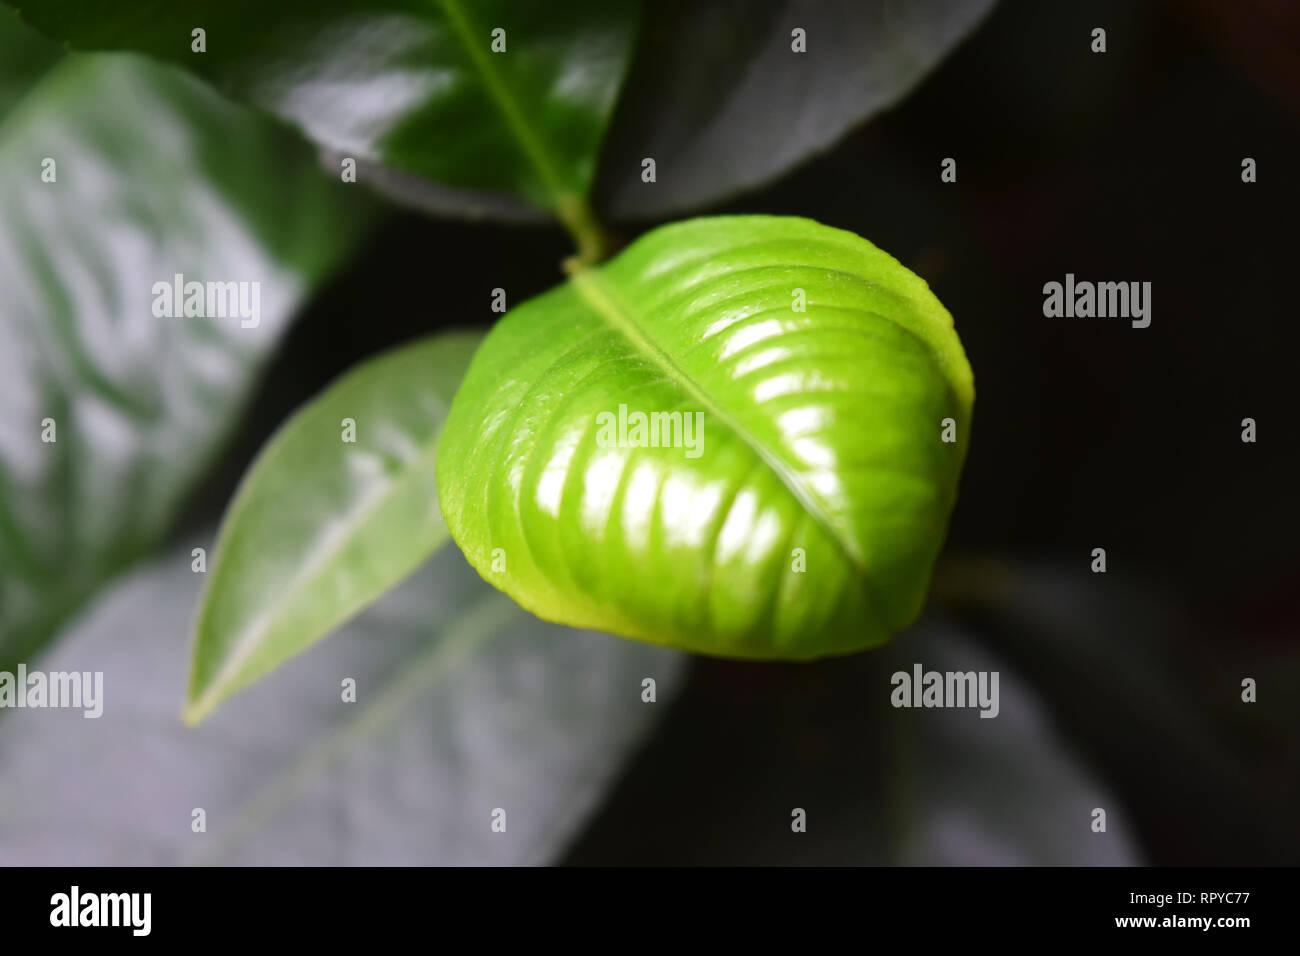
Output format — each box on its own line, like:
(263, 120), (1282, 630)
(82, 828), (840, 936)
(186, 333), (481, 722)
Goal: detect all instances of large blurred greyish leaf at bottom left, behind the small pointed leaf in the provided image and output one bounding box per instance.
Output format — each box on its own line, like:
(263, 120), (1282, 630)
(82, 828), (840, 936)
(0, 549), (685, 865)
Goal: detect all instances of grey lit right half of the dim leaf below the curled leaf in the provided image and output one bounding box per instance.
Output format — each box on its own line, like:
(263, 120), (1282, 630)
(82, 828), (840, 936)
(883, 615), (1140, 866)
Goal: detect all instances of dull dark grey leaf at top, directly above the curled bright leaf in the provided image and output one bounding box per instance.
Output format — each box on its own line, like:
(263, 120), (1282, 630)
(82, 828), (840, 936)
(597, 0), (995, 218)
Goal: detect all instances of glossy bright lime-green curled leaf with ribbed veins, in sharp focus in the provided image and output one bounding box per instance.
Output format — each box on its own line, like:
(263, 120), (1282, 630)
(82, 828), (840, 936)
(438, 216), (974, 658)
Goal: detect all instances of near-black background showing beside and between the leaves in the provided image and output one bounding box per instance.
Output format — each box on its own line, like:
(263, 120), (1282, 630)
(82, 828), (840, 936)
(178, 0), (1300, 864)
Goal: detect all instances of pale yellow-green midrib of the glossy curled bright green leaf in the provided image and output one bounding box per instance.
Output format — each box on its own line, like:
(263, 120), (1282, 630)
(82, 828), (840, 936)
(569, 261), (867, 579)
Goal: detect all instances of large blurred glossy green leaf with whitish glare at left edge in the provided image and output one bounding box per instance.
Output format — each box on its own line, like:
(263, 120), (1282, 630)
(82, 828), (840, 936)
(0, 9), (369, 670)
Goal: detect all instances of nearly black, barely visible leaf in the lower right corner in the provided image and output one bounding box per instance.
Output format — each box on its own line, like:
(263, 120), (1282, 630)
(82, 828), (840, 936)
(949, 561), (1300, 865)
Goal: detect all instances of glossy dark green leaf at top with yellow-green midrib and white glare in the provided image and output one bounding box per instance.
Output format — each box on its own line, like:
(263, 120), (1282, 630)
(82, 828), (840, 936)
(10, 0), (641, 239)
